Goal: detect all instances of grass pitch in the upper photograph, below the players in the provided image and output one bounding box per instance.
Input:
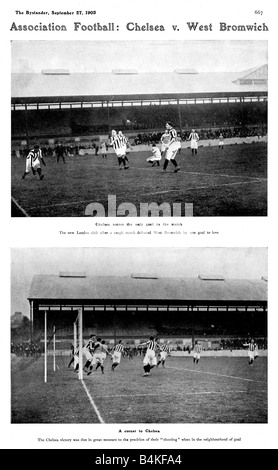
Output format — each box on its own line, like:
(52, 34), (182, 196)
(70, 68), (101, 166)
(11, 142), (267, 217)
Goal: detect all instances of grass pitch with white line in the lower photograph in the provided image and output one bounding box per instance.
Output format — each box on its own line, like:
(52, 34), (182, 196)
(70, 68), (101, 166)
(11, 356), (268, 424)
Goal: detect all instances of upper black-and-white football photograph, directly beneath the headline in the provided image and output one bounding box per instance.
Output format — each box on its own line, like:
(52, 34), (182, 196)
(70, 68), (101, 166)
(11, 40), (268, 217)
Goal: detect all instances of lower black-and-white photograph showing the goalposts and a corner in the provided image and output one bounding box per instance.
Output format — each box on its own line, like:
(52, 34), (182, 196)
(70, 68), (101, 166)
(10, 247), (268, 424)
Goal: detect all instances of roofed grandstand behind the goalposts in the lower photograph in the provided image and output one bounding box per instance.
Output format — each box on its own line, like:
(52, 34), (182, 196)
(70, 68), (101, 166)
(28, 272), (267, 349)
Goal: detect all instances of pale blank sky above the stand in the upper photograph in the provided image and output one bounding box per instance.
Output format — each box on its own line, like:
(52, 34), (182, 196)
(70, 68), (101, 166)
(11, 40), (268, 73)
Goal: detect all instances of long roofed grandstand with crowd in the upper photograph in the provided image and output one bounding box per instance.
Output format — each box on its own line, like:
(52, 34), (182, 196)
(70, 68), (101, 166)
(11, 65), (268, 150)
